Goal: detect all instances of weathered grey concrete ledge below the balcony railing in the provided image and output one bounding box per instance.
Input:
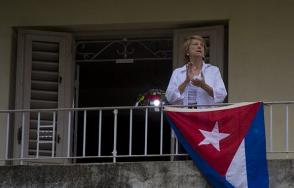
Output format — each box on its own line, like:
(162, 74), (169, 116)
(0, 160), (294, 188)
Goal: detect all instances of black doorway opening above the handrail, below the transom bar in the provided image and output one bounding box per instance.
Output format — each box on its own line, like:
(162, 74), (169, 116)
(79, 61), (172, 107)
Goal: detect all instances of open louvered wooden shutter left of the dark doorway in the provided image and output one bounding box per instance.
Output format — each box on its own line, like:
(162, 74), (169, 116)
(16, 30), (73, 162)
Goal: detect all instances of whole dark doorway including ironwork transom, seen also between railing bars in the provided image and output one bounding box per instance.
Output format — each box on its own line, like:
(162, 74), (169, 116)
(76, 38), (172, 162)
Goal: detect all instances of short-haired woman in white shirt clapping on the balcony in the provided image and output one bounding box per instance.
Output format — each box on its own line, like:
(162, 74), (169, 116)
(166, 35), (227, 105)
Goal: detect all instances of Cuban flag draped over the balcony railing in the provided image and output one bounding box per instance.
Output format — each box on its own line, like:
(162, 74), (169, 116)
(164, 102), (269, 188)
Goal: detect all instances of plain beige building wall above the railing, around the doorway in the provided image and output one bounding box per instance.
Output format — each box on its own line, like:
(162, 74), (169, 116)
(0, 0), (294, 159)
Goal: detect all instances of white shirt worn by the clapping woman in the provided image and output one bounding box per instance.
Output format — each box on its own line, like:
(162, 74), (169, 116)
(165, 62), (227, 105)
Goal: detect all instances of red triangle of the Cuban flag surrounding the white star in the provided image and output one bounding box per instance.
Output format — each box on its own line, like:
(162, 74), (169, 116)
(167, 103), (260, 176)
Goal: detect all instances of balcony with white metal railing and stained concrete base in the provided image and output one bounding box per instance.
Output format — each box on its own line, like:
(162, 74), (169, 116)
(0, 101), (294, 188)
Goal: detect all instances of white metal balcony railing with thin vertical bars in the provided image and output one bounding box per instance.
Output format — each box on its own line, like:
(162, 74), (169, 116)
(0, 101), (294, 164)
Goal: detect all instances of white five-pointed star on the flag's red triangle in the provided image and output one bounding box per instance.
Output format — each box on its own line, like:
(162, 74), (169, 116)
(198, 122), (230, 151)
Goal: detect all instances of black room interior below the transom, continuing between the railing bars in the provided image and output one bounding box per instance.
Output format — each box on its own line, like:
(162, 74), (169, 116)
(77, 37), (172, 162)
